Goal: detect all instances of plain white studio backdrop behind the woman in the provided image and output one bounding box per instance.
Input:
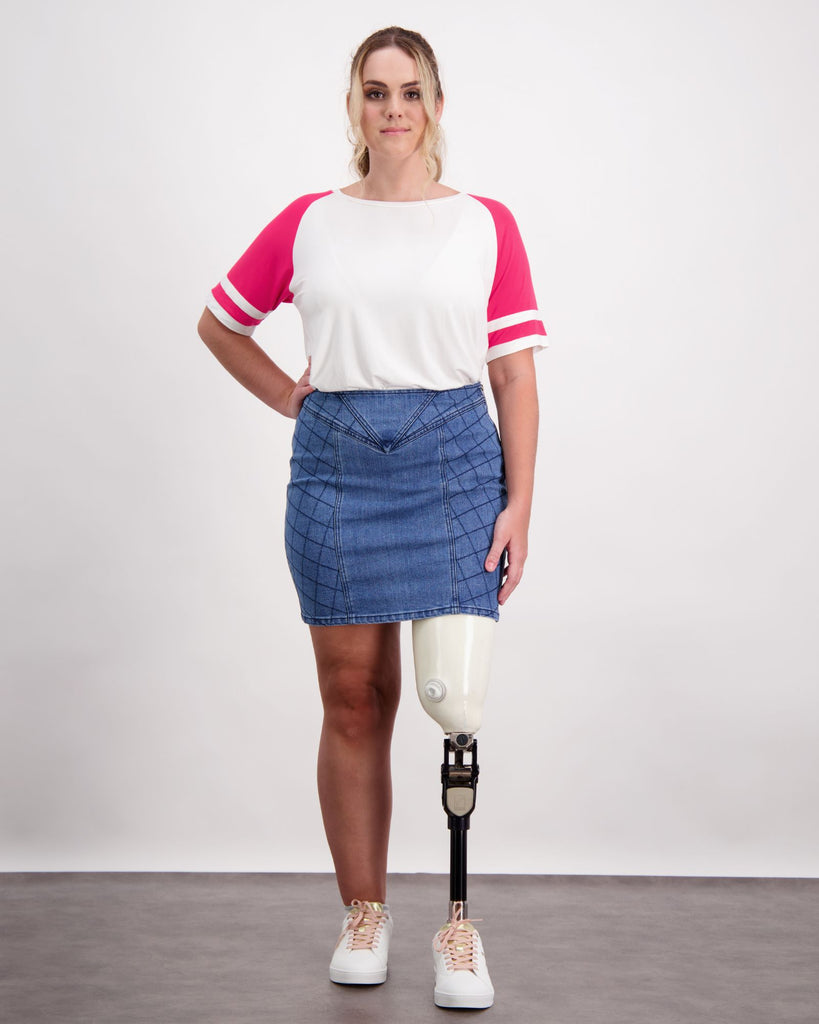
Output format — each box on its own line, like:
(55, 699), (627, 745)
(0, 0), (819, 877)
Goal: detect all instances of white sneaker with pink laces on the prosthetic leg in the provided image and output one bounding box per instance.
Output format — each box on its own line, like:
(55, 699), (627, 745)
(432, 910), (494, 1010)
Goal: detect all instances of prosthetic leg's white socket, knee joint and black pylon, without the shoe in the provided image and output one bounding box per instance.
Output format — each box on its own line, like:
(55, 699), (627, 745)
(413, 615), (495, 921)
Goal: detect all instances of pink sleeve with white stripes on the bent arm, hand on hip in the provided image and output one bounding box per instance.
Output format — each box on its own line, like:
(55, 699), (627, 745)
(207, 191), (329, 335)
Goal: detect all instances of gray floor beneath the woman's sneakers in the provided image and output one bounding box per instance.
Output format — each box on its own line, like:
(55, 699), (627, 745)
(0, 873), (819, 1024)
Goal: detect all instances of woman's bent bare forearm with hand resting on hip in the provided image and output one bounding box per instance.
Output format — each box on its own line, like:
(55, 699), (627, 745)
(199, 308), (315, 419)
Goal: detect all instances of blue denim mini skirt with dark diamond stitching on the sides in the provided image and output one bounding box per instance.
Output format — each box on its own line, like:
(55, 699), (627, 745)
(285, 383), (506, 626)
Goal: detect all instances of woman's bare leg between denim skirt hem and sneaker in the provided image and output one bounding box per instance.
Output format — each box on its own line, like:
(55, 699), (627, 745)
(310, 623), (401, 904)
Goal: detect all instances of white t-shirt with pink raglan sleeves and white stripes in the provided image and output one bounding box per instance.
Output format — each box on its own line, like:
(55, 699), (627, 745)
(208, 189), (546, 391)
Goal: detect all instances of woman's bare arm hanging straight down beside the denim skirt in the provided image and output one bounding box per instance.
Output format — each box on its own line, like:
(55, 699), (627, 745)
(484, 348), (537, 604)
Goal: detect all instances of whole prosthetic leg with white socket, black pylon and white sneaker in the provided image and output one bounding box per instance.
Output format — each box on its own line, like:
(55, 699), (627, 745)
(413, 615), (495, 1009)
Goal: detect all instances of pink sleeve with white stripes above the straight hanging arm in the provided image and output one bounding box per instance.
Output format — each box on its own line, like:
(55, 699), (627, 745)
(474, 196), (548, 362)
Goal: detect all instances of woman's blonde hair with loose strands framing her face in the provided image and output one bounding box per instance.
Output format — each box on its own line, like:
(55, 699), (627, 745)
(347, 25), (443, 181)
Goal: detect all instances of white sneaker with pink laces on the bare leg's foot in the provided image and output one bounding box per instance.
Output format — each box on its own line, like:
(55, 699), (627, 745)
(330, 899), (392, 985)
